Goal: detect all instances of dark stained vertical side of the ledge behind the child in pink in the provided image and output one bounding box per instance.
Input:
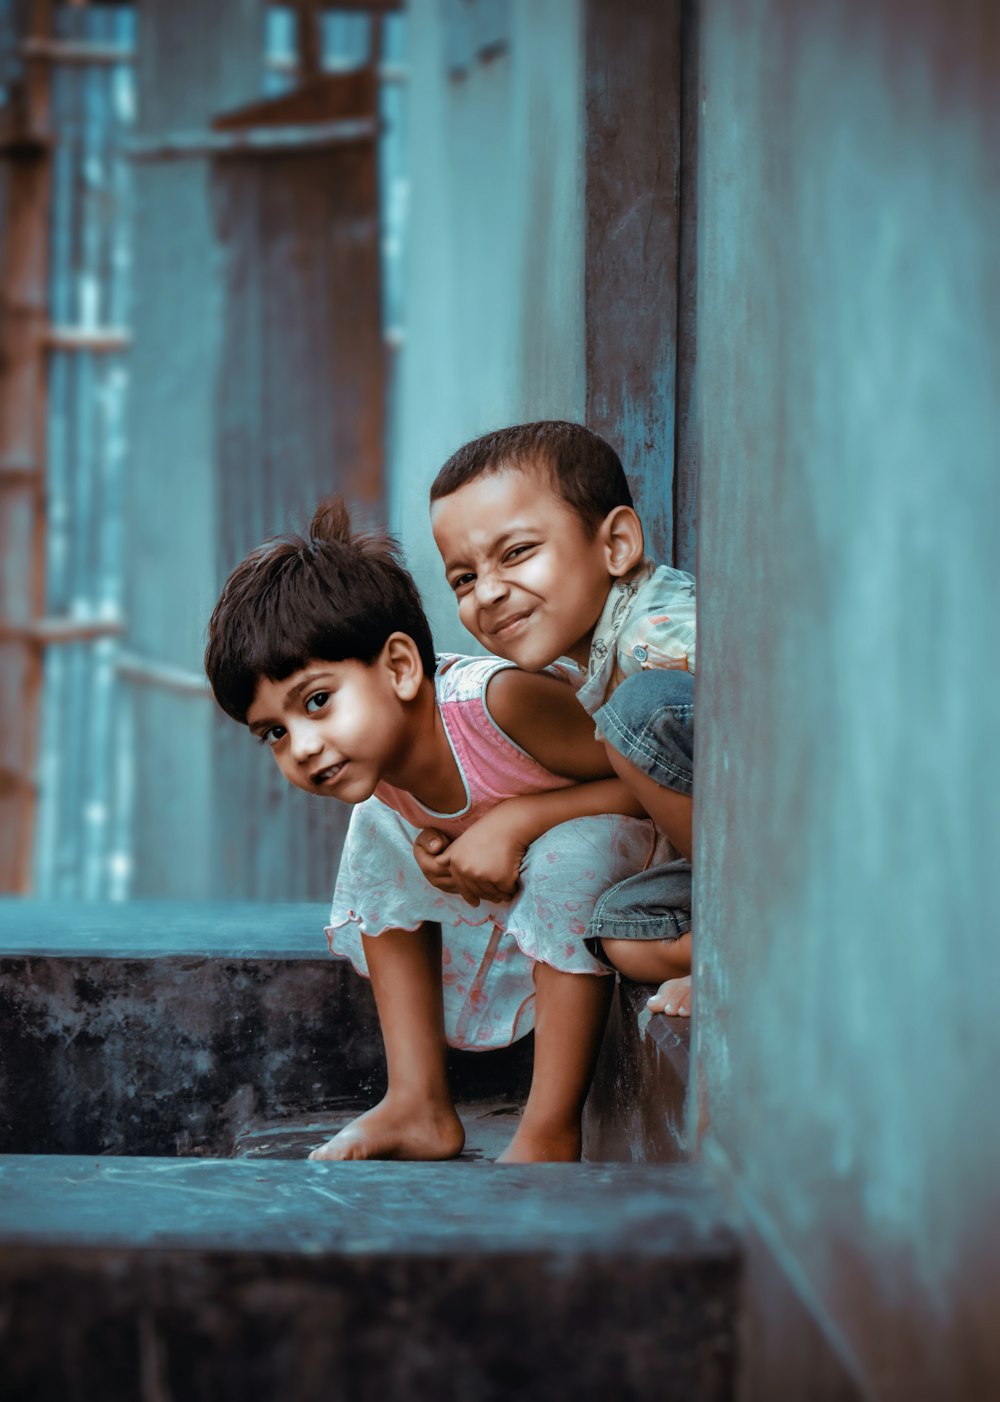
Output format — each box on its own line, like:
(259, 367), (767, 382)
(0, 956), (381, 1154)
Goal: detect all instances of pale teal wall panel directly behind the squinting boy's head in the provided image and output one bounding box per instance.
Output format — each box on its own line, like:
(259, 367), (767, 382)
(390, 0), (585, 652)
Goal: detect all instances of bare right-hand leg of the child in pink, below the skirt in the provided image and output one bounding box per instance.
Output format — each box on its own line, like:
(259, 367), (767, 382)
(499, 963), (614, 1164)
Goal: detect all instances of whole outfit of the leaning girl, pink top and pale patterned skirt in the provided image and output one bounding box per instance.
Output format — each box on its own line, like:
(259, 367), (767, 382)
(327, 656), (656, 1050)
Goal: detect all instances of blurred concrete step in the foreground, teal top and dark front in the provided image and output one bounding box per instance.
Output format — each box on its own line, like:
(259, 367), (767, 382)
(0, 1158), (738, 1402)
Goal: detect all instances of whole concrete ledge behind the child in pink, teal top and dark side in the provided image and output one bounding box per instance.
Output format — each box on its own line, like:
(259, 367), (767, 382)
(0, 901), (532, 1155)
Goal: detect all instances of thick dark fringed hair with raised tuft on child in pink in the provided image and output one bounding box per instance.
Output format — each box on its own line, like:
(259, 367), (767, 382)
(205, 498), (435, 723)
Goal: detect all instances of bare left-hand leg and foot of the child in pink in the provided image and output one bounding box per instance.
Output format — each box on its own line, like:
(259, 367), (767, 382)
(309, 924), (466, 1159)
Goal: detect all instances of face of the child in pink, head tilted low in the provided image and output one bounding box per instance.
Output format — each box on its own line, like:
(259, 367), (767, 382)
(247, 645), (408, 803)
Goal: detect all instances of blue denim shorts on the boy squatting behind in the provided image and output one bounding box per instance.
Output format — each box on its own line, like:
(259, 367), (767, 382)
(588, 669), (694, 939)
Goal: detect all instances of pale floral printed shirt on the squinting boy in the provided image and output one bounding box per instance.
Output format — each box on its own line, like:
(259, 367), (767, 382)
(576, 559), (694, 715)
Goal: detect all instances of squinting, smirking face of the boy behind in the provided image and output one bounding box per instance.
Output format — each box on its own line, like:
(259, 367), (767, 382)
(431, 467), (612, 672)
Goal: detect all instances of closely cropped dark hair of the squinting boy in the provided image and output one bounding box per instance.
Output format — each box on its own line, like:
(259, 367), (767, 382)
(431, 419), (634, 536)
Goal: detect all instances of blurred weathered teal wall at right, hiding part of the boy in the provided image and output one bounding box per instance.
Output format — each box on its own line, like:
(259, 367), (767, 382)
(697, 0), (1000, 1399)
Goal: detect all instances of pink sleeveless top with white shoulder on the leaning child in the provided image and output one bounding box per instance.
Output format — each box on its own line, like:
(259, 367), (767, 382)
(374, 653), (572, 837)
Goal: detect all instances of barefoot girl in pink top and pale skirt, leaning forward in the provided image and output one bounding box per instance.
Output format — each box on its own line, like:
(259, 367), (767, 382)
(205, 501), (655, 1161)
